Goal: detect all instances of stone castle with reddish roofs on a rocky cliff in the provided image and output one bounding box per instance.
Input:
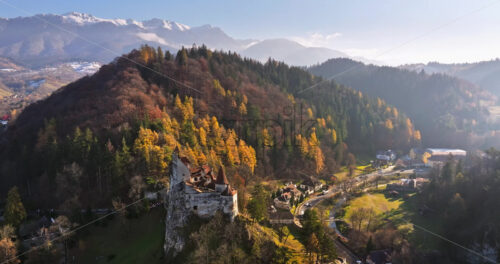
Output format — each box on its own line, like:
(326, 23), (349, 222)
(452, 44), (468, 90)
(165, 149), (238, 255)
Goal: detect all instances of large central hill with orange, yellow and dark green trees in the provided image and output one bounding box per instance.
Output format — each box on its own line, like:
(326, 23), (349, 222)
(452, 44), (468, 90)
(0, 46), (420, 208)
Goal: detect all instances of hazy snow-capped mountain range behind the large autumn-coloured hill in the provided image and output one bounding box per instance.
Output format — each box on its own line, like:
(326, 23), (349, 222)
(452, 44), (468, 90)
(0, 12), (347, 67)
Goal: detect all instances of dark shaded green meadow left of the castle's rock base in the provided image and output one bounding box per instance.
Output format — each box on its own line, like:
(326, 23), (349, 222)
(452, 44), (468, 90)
(69, 208), (165, 264)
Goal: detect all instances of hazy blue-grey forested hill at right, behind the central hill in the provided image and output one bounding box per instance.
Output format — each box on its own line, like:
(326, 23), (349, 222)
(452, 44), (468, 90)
(309, 59), (496, 148)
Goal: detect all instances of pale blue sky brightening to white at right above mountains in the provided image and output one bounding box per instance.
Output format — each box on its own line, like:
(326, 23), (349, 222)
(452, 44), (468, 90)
(0, 0), (500, 65)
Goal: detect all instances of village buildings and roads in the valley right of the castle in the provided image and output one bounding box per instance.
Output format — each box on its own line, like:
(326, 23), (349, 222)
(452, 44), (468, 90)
(269, 145), (468, 263)
